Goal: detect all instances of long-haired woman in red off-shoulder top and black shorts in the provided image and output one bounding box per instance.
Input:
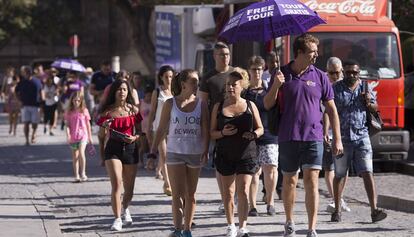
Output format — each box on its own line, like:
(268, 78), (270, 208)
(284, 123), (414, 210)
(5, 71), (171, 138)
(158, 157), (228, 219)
(98, 80), (142, 231)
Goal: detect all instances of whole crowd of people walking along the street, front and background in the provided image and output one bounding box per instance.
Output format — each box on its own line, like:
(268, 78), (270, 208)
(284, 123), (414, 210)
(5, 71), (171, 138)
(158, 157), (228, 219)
(2, 34), (387, 237)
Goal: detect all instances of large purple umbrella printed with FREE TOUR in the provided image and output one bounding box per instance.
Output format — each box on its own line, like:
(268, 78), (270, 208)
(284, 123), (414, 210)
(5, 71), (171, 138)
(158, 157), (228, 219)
(219, 0), (326, 43)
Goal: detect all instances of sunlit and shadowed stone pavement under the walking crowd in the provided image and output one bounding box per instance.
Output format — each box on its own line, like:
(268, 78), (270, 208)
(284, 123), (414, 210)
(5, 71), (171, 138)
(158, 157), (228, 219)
(0, 115), (414, 237)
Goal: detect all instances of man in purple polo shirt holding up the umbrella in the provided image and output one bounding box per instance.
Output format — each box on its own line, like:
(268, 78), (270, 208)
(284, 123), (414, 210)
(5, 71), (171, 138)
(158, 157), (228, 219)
(264, 34), (343, 237)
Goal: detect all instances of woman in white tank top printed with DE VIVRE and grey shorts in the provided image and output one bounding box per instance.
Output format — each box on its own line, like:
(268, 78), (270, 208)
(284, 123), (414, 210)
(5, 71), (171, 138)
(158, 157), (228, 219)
(151, 69), (210, 237)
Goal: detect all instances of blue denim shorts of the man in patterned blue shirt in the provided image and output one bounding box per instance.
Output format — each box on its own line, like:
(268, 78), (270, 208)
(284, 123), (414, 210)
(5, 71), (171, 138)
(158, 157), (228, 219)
(334, 137), (373, 178)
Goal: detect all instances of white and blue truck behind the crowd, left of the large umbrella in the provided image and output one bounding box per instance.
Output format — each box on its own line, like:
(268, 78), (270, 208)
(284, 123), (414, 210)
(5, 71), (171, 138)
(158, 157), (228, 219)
(155, 5), (223, 75)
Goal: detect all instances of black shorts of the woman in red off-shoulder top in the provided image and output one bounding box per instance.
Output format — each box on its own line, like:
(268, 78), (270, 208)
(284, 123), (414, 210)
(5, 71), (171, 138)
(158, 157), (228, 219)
(105, 139), (139, 165)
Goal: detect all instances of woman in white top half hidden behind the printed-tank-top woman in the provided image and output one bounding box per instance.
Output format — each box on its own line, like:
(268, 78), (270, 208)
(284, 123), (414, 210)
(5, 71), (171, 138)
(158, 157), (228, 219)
(146, 65), (175, 196)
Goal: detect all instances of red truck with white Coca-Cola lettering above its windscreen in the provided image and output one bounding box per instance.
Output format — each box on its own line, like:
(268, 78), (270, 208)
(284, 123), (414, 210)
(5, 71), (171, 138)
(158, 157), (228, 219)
(290, 0), (409, 160)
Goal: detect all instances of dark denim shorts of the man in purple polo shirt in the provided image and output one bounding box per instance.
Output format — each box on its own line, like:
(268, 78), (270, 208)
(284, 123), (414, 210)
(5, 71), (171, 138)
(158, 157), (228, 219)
(279, 141), (323, 175)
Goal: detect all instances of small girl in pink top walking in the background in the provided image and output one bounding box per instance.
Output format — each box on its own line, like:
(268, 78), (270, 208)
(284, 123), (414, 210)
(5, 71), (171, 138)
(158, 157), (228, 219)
(65, 91), (92, 183)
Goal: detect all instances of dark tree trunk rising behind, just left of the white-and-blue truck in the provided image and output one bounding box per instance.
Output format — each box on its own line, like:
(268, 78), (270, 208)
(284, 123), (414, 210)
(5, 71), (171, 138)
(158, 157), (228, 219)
(112, 0), (222, 72)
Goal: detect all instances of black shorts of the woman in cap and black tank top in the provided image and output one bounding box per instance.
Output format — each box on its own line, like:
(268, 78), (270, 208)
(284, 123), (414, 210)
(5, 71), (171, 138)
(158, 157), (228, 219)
(214, 142), (259, 176)
